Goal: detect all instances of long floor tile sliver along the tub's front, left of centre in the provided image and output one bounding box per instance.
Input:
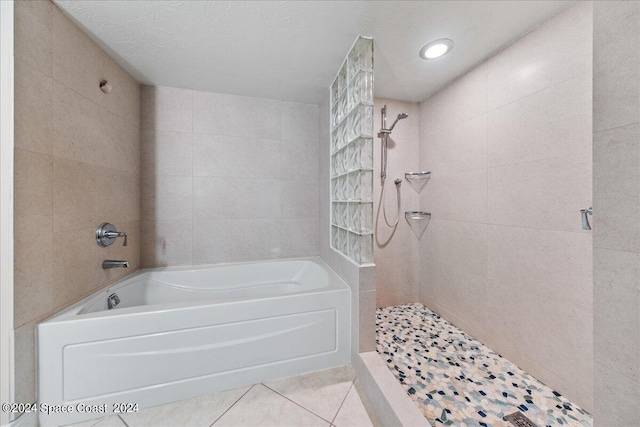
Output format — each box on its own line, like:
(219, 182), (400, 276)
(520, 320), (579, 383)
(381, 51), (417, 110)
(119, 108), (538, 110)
(121, 387), (250, 427)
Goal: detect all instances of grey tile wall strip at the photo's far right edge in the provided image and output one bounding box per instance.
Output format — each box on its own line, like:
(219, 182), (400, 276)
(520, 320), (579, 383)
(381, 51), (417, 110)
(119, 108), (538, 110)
(593, 1), (640, 427)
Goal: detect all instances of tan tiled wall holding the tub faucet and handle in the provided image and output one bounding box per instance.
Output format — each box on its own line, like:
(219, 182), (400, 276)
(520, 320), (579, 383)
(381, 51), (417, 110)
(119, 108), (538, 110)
(14, 0), (140, 402)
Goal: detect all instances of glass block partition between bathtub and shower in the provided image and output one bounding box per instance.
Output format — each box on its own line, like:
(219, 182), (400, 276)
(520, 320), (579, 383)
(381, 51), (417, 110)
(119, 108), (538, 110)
(331, 37), (373, 264)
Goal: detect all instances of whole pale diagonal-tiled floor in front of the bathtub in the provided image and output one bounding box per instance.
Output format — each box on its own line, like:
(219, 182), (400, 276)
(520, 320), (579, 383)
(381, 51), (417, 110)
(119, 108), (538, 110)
(62, 366), (373, 427)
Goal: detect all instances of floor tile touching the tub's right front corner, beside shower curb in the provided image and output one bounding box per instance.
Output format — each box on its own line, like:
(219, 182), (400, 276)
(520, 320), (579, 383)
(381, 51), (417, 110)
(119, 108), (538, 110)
(265, 366), (355, 421)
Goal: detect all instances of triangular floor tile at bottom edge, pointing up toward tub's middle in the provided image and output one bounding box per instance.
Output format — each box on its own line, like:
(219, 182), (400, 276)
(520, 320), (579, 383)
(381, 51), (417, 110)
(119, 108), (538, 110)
(215, 384), (329, 427)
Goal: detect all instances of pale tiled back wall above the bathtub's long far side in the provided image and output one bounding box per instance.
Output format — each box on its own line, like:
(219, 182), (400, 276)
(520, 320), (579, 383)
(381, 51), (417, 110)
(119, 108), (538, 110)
(141, 86), (319, 267)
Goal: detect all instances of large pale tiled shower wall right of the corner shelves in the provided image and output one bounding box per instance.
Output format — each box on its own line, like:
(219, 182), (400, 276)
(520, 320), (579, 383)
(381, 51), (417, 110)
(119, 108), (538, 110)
(420, 2), (592, 411)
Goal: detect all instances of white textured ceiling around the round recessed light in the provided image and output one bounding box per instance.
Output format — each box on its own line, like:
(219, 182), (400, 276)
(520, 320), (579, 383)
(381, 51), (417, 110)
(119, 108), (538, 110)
(54, 0), (571, 104)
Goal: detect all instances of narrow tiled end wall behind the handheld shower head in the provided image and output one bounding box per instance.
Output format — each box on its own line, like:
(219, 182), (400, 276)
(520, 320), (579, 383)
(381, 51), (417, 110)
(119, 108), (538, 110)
(373, 98), (425, 307)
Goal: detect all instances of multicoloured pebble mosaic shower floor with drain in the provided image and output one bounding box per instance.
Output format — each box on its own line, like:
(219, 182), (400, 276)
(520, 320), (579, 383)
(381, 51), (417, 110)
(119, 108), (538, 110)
(376, 304), (593, 427)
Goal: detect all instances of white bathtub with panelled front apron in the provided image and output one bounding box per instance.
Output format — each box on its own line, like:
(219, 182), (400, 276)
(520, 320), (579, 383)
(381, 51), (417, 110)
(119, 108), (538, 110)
(37, 258), (350, 426)
